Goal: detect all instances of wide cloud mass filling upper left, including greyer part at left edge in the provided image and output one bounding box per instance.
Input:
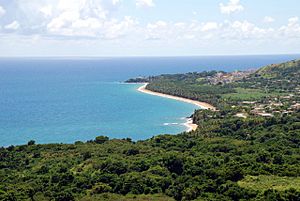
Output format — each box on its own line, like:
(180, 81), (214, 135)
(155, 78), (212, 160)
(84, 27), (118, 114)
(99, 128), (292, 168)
(2, 0), (138, 40)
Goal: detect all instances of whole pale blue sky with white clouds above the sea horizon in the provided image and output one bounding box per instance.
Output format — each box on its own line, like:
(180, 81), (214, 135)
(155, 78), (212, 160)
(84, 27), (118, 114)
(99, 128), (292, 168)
(0, 0), (300, 57)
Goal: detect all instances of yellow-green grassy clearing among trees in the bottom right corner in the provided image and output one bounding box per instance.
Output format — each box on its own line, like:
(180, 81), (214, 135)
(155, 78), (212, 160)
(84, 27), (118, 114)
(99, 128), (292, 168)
(238, 175), (300, 191)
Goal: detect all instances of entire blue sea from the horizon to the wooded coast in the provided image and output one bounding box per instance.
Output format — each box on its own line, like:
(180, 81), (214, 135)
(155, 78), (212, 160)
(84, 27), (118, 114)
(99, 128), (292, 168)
(0, 55), (300, 146)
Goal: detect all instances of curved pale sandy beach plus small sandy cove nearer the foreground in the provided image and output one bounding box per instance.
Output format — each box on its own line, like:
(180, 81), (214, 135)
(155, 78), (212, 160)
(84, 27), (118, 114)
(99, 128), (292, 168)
(137, 83), (216, 132)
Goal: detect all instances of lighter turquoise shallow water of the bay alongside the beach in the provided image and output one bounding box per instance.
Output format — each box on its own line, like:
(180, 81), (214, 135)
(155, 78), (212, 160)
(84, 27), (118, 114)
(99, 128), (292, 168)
(0, 82), (195, 145)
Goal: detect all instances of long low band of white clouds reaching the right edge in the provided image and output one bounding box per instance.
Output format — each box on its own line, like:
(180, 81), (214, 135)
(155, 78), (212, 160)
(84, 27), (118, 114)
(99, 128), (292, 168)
(143, 18), (288, 42)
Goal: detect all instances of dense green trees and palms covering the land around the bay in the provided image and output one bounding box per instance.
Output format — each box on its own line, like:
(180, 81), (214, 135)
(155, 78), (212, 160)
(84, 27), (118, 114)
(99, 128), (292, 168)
(0, 59), (300, 201)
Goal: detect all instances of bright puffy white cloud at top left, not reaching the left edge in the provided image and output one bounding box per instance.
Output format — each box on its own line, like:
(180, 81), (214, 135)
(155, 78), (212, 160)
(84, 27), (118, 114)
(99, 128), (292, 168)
(43, 0), (138, 39)
